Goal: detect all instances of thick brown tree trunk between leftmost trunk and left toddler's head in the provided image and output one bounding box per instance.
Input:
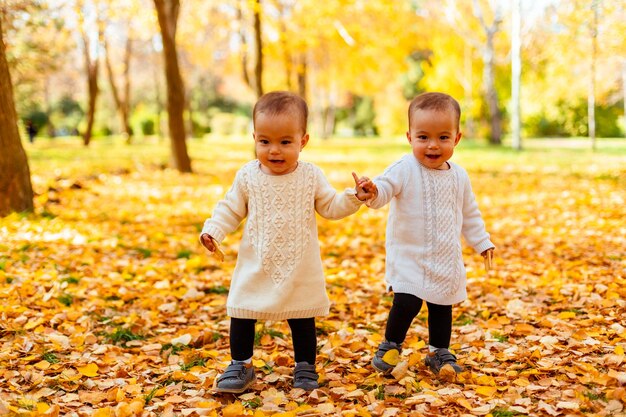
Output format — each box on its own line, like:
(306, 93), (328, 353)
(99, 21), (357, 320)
(154, 0), (191, 172)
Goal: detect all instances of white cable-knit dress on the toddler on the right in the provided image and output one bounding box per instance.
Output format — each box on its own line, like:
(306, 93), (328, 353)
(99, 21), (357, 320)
(367, 154), (494, 305)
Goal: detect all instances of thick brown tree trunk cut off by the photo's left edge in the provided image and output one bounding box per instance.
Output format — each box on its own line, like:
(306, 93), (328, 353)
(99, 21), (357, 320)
(0, 19), (33, 216)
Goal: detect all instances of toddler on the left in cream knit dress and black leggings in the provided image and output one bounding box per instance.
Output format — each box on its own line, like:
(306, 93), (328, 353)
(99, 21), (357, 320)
(200, 91), (372, 393)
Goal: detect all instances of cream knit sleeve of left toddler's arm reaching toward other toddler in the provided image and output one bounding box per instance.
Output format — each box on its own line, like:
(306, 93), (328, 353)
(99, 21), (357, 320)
(315, 167), (363, 220)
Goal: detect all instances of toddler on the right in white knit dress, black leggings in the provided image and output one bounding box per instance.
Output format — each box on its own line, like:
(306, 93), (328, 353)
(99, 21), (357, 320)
(359, 93), (494, 379)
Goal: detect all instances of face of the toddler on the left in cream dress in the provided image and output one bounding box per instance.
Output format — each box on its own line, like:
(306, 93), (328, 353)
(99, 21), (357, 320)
(253, 113), (309, 175)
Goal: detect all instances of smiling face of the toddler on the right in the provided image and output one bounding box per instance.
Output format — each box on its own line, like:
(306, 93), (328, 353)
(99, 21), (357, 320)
(406, 110), (461, 169)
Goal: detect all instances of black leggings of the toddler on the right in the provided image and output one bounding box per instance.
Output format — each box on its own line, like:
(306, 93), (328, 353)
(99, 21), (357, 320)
(385, 293), (452, 348)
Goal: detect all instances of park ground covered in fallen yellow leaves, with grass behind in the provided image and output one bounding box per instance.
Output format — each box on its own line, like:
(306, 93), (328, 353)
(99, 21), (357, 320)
(0, 141), (626, 417)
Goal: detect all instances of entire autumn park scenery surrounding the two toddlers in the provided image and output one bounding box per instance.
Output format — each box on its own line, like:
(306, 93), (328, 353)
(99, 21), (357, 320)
(0, 0), (626, 417)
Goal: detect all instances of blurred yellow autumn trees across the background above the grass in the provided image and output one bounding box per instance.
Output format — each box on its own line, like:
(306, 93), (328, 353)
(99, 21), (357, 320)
(0, 0), (626, 146)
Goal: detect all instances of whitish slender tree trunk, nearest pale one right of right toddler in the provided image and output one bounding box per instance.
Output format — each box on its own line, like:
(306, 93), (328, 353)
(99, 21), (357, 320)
(511, 0), (522, 150)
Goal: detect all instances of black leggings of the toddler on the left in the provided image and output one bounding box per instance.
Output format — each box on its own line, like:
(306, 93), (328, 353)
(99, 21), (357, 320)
(230, 317), (317, 365)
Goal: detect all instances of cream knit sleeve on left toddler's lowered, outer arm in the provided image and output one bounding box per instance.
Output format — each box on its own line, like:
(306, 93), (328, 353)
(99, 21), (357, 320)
(202, 171), (248, 242)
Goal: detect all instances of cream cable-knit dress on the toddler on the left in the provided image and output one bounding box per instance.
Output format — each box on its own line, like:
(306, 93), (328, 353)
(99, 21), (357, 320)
(202, 160), (362, 320)
